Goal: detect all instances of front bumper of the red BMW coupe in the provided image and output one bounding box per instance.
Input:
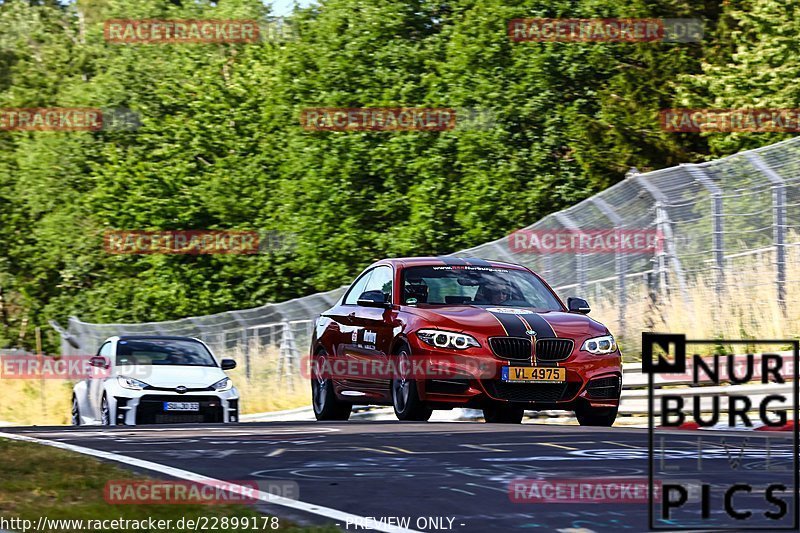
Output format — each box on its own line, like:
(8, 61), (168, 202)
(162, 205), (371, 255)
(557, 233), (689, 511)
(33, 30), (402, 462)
(412, 341), (622, 410)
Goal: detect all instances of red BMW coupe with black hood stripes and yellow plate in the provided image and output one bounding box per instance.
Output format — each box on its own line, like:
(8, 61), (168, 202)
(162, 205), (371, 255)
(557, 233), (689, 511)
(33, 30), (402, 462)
(310, 257), (622, 426)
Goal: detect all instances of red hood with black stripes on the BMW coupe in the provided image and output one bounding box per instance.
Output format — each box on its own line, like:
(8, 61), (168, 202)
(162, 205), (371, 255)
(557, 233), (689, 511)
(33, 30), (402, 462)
(408, 304), (608, 338)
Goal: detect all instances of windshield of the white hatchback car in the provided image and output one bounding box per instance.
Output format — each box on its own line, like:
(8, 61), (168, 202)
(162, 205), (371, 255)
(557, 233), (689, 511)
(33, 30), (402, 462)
(117, 339), (217, 366)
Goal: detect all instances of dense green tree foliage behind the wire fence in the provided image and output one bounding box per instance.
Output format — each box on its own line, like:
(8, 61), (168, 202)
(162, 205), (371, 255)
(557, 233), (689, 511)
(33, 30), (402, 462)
(0, 0), (800, 347)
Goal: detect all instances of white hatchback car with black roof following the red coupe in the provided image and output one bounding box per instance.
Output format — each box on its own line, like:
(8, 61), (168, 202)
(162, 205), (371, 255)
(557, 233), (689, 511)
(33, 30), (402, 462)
(72, 336), (239, 426)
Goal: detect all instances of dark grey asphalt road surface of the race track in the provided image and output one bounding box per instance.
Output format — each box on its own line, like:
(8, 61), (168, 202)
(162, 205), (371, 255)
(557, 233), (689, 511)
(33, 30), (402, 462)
(3, 421), (797, 532)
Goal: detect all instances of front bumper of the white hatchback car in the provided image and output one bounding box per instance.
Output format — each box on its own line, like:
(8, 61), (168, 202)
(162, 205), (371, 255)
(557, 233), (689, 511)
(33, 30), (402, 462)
(109, 388), (239, 426)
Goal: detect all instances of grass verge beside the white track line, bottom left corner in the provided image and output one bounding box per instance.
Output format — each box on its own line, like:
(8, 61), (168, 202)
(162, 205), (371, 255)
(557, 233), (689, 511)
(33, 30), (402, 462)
(0, 439), (338, 533)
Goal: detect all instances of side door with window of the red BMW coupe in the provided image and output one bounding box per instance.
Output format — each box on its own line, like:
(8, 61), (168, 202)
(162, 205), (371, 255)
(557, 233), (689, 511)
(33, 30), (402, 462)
(348, 265), (394, 392)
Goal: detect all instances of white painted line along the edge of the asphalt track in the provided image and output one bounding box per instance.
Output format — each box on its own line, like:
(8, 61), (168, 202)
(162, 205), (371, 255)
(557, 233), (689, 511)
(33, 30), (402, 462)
(0, 433), (420, 533)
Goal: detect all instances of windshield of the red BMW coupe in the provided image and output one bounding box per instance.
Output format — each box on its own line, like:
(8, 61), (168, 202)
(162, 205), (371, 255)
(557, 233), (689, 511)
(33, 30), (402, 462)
(402, 265), (564, 311)
